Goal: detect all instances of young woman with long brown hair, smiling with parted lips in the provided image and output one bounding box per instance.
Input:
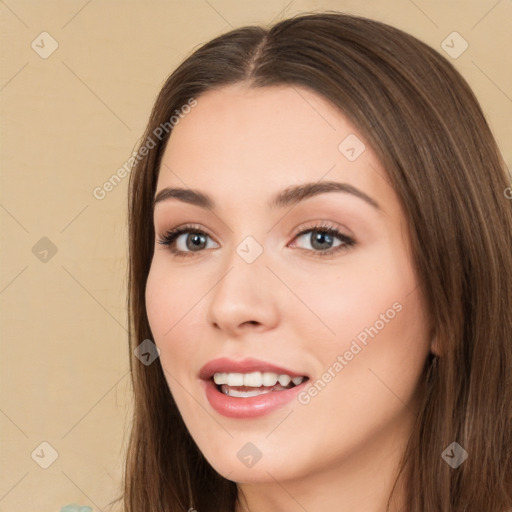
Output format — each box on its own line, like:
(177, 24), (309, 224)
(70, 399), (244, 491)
(123, 13), (512, 512)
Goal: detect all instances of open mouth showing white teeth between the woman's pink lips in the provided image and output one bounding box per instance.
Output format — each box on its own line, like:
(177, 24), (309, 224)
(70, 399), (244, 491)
(211, 372), (308, 398)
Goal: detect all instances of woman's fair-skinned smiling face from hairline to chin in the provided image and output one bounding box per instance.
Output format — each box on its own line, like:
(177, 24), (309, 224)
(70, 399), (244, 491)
(146, 84), (430, 483)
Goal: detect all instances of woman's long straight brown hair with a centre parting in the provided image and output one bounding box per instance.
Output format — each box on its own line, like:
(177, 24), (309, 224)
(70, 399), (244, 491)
(122, 12), (512, 512)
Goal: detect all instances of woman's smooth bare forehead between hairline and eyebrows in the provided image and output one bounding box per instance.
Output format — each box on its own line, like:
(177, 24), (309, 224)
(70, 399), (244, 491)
(157, 84), (394, 216)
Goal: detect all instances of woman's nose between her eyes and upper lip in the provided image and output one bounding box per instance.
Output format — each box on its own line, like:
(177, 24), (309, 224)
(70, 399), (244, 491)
(208, 244), (279, 337)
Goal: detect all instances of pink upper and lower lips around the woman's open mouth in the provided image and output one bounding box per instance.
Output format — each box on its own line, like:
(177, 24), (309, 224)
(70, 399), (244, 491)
(199, 358), (309, 418)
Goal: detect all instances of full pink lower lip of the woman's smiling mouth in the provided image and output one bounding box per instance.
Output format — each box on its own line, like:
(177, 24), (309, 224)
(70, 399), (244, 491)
(201, 379), (308, 418)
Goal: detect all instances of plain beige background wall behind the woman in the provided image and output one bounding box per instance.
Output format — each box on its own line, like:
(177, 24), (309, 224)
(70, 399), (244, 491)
(0, 0), (512, 512)
